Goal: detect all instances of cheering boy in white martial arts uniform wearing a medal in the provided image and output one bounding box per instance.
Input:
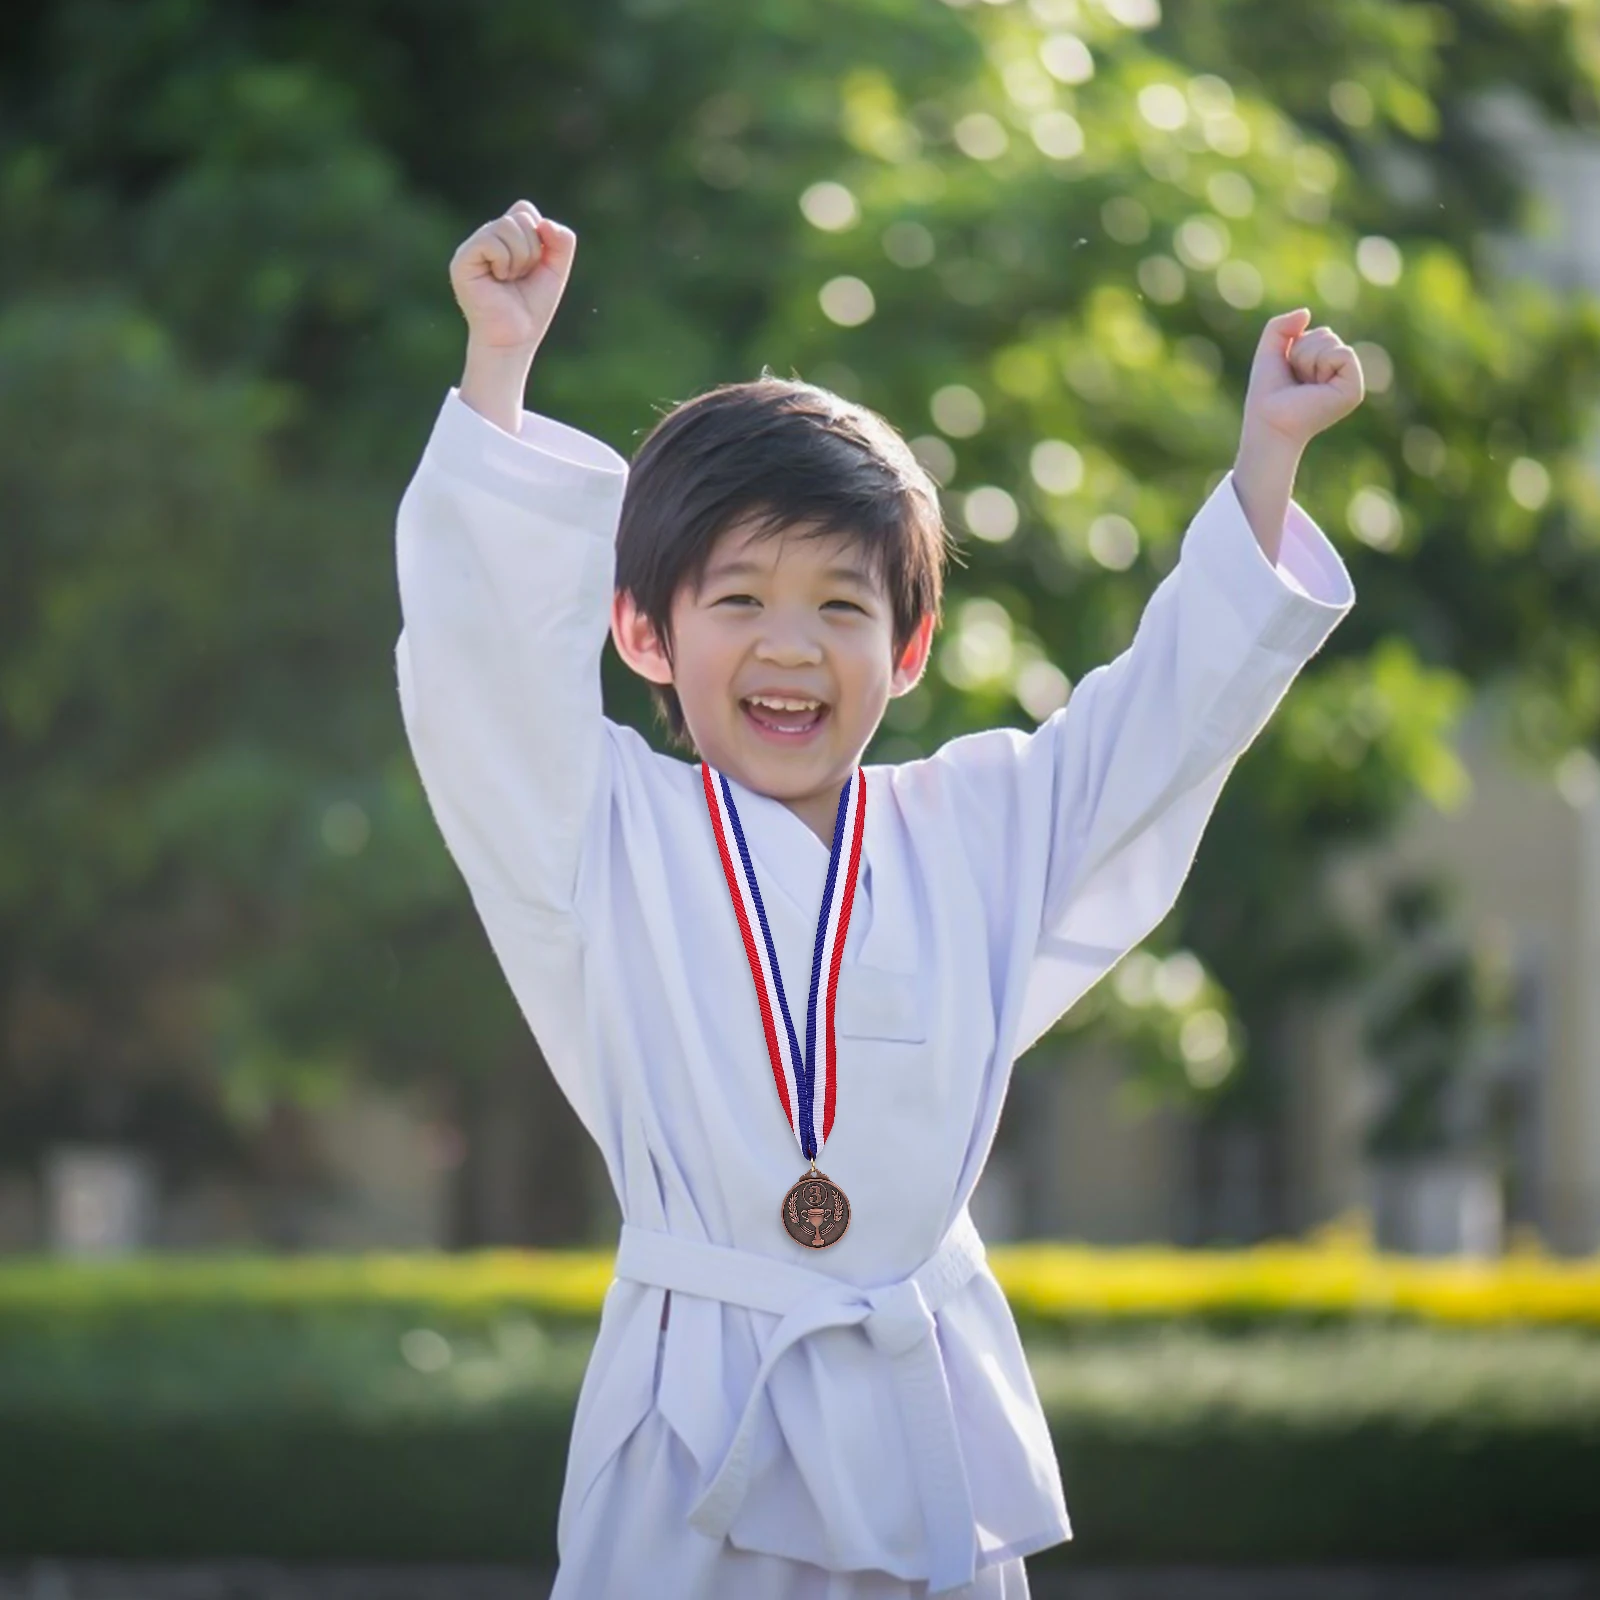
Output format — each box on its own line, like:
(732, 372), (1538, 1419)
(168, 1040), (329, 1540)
(397, 200), (1362, 1600)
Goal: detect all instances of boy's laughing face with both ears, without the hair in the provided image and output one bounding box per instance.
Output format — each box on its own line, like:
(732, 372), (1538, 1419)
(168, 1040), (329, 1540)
(613, 525), (933, 837)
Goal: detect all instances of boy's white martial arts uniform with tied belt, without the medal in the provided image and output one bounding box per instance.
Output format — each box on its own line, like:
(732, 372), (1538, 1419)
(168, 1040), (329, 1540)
(395, 389), (1354, 1600)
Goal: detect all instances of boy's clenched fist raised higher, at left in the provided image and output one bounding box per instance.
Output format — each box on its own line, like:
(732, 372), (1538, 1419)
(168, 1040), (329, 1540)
(450, 200), (578, 357)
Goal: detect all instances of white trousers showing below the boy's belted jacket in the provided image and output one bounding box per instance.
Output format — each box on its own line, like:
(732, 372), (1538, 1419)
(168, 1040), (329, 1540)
(550, 1410), (1027, 1600)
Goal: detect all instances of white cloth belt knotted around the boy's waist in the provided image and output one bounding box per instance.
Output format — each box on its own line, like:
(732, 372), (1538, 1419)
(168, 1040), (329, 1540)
(616, 1211), (984, 1594)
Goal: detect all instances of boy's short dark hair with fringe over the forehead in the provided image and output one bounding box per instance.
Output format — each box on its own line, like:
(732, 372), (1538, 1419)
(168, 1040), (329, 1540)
(616, 371), (949, 749)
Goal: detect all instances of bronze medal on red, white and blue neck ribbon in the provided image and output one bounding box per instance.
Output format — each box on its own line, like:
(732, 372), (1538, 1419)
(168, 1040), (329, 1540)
(701, 762), (867, 1250)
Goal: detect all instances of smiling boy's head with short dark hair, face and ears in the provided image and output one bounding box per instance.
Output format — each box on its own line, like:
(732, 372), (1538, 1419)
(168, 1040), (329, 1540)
(611, 379), (947, 845)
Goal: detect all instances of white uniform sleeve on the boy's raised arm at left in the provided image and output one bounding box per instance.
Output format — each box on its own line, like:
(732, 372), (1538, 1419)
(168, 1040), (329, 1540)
(395, 389), (627, 922)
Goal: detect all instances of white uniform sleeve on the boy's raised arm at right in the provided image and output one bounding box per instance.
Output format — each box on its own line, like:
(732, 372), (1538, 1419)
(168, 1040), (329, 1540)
(915, 472), (1355, 1053)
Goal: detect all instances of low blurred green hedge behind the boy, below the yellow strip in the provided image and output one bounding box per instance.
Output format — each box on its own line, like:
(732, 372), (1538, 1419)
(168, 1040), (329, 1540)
(0, 1258), (1600, 1566)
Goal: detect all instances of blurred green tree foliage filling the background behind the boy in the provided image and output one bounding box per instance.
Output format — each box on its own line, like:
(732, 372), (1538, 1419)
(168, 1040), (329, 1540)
(0, 0), (1600, 1238)
